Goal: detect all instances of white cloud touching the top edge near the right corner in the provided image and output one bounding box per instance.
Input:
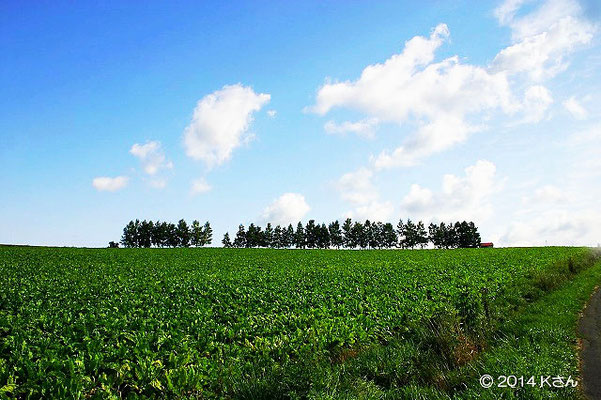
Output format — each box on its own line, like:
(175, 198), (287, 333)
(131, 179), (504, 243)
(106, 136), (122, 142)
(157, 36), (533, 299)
(492, 0), (597, 81)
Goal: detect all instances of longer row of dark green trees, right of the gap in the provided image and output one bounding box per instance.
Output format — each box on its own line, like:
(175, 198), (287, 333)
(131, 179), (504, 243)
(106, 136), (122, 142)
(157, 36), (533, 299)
(221, 218), (480, 249)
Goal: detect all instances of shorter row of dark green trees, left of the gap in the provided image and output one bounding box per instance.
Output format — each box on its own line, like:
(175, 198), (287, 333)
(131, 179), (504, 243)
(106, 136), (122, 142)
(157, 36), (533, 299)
(119, 219), (213, 247)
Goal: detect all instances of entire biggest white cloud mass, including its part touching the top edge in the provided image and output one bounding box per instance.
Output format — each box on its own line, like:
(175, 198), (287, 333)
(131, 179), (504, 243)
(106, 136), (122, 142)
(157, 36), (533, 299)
(305, 0), (597, 169)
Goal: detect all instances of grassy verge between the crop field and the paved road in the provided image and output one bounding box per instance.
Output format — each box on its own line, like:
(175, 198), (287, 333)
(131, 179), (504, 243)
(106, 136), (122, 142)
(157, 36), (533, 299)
(258, 250), (601, 400)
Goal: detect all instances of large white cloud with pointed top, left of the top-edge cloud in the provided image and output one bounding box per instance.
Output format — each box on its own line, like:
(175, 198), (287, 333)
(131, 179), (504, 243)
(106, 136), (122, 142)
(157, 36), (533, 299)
(307, 24), (510, 168)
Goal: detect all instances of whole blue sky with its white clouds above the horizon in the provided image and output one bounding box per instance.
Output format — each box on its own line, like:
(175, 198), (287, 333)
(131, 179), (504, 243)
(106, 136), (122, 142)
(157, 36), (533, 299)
(0, 0), (601, 246)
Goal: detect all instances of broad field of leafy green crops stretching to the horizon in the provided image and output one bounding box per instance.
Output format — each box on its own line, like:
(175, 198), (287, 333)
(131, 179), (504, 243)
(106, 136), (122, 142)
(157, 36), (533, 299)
(0, 247), (588, 398)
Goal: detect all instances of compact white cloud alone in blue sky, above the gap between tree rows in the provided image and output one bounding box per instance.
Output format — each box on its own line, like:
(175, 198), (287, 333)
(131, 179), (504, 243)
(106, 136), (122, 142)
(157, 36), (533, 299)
(184, 84), (270, 168)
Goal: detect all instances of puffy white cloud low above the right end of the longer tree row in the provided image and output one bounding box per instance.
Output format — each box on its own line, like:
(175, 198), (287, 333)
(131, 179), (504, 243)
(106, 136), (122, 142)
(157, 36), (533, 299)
(401, 160), (501, 222)
